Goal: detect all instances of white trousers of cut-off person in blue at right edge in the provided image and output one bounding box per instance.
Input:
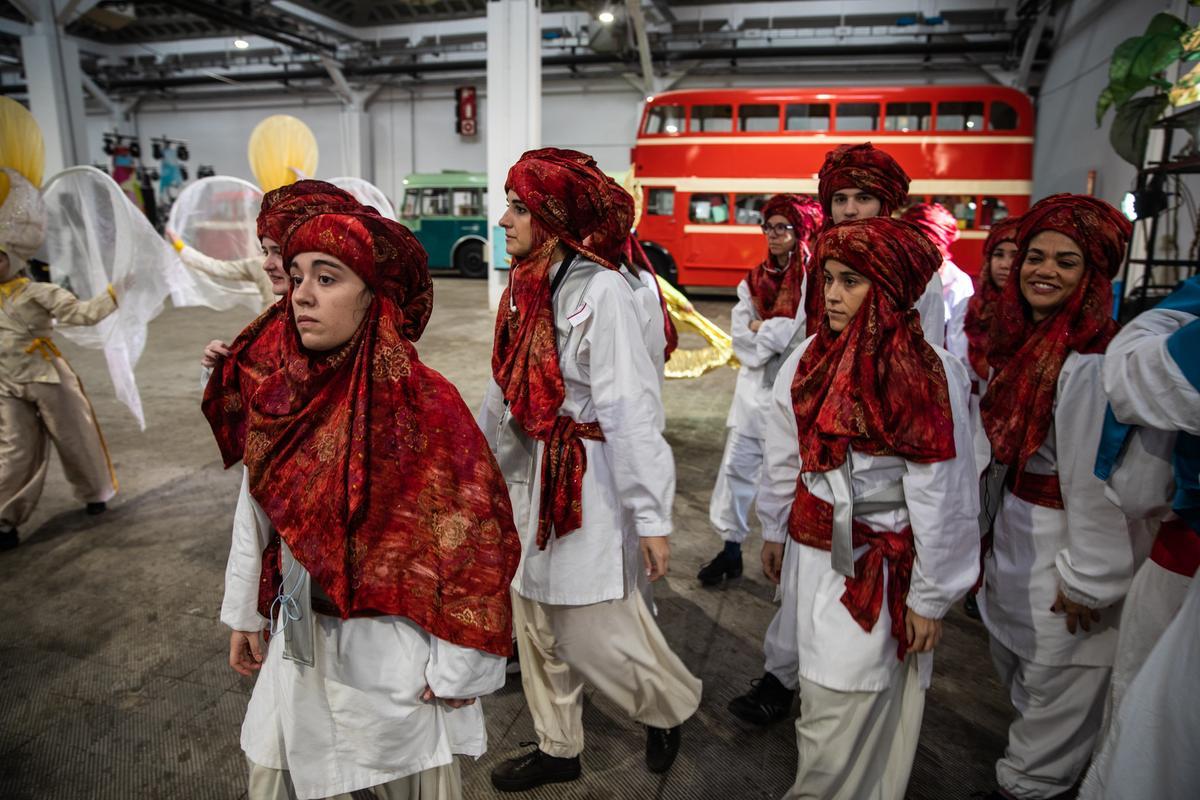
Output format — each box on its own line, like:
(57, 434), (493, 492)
(1079, 560), (1200, 800)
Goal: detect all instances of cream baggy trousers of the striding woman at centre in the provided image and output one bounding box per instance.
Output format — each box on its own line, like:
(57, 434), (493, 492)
(512, 591), (701, 758)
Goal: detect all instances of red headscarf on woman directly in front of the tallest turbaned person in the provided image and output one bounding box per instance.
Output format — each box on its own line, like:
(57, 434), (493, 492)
(792, 217), (954, 473)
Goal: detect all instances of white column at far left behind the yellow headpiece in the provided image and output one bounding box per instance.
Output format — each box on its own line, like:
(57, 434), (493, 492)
(20, 0), (88, 176)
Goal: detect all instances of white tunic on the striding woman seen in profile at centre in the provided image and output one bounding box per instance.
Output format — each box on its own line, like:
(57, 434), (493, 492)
(479, 265), (674, 606)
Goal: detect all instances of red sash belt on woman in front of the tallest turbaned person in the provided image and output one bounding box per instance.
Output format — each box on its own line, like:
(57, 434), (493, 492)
(787, 477), (917, 661)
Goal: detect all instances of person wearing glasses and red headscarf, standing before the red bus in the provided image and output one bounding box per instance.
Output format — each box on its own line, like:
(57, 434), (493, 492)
(696, 194), (824, 587)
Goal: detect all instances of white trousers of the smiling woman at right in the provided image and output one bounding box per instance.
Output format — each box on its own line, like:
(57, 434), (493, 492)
(990, 638), (1112, 800)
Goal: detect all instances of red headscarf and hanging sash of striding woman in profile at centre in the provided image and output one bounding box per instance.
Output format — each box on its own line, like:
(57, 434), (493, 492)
(492, 148), (634, 547)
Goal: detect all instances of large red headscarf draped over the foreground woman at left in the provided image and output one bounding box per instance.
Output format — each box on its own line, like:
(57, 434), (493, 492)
(204, 204), (521, 655)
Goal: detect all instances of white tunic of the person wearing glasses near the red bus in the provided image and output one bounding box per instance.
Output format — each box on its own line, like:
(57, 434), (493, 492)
(725, 275), (808, 439)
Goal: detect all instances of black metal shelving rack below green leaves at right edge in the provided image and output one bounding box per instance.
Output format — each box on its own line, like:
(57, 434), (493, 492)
(1117, 106), (1200, 320)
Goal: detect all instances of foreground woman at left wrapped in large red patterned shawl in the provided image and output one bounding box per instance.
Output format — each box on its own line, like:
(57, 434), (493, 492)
(204, 196), (520, 798)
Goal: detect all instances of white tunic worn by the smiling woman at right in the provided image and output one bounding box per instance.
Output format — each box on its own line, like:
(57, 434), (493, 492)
(979, 353), (1146, 667)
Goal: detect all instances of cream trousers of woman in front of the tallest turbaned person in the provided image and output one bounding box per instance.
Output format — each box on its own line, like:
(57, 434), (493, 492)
(784, 658), (925, 800)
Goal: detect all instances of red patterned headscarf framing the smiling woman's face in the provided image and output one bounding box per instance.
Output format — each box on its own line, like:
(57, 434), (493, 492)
(980, 194), (1133, 467)
